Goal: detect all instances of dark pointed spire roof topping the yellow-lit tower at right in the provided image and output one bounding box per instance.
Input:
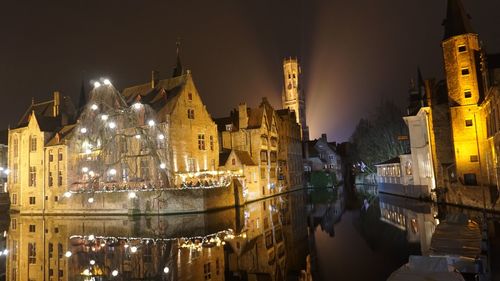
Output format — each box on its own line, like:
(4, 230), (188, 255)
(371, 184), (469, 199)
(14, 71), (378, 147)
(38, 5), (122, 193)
(443, 0), (475, 40)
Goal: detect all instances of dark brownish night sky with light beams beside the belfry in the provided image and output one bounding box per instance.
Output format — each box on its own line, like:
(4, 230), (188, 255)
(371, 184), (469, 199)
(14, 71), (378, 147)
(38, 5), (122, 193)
(0, 0), (500, 141)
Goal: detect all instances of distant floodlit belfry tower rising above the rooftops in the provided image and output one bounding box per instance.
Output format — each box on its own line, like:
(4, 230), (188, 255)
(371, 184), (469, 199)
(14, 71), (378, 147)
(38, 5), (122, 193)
(281, 58), (309, 141)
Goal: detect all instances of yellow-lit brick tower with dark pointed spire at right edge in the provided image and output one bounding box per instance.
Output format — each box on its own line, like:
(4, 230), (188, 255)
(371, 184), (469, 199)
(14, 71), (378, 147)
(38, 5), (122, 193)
(441, 0), (485, 185)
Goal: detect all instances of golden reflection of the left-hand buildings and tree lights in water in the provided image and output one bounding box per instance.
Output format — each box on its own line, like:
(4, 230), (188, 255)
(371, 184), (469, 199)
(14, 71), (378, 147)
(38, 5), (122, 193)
(2, 190), (308, 281)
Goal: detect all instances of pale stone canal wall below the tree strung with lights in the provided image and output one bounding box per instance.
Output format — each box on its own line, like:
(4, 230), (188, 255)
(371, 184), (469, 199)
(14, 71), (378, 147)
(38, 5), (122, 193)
(19, 179), (245, 215)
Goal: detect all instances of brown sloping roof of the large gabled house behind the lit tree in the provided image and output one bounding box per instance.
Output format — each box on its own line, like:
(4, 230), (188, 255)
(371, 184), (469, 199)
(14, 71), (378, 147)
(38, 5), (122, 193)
(122, 74), (190, 114)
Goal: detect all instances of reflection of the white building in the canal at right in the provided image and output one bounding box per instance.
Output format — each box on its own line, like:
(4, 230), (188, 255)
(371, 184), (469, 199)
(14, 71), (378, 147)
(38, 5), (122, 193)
(379, 194), (439, 255)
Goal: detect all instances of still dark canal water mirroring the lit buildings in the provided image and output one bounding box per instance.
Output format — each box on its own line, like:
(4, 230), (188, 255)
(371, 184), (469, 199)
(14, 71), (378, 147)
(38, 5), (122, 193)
(0, 187), (500, 281)
